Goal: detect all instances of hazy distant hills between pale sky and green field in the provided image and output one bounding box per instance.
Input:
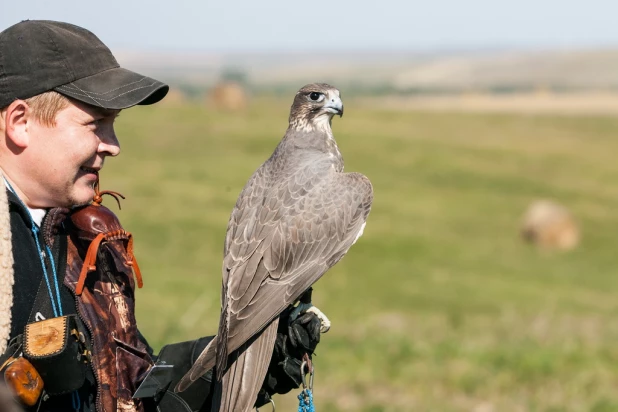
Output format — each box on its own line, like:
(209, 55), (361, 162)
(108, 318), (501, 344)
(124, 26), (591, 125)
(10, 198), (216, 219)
(119, 48), (618, 93)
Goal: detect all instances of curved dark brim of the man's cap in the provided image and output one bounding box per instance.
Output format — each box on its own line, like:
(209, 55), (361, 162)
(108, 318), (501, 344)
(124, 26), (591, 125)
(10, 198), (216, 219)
(54, 67), (169, 110)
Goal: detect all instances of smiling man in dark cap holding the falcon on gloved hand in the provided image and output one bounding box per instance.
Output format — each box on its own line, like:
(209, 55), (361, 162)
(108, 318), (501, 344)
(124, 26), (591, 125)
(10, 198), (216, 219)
(0, 21), (320, 412)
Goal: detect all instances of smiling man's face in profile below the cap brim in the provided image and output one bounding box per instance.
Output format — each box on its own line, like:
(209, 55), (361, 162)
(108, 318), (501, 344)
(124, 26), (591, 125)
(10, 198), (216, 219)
(24, 102), (120, 207)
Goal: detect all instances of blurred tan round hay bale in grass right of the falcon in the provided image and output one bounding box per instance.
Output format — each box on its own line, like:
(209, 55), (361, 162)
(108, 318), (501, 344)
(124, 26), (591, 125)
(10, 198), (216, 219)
(521, 200), (580, 250)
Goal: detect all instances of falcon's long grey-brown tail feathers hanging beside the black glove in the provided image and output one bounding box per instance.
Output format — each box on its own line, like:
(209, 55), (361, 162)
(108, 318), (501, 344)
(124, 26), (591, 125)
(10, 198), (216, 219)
(211, 317), (279, 412)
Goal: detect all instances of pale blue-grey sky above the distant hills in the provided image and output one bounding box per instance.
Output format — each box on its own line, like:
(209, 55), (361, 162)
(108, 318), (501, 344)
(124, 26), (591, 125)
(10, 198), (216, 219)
(0, 0), (618, 52)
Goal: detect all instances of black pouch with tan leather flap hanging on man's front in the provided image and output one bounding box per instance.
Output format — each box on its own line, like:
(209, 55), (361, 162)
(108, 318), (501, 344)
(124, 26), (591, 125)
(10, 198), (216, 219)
(23, 315), (88, 395)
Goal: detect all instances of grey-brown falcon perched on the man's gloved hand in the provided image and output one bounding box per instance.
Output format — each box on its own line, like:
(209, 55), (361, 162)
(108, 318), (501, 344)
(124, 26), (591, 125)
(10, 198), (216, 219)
(176, 83), (373, 412)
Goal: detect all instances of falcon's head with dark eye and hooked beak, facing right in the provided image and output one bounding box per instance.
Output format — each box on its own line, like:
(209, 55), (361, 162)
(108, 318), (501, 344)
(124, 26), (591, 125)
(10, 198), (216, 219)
(290, 83), (343, 132)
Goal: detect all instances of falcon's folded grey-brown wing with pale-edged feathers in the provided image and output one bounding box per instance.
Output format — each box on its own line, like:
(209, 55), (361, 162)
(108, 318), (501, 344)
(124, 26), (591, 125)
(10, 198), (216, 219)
(217, 167), (373, 366)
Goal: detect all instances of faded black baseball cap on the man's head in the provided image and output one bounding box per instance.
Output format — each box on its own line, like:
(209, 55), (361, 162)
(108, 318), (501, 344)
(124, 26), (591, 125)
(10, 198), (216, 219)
(0, 20), (169, 109)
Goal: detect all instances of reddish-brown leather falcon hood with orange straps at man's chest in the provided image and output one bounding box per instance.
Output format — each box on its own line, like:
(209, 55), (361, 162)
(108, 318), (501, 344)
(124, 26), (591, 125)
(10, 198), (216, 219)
(70, 182), (143, 295)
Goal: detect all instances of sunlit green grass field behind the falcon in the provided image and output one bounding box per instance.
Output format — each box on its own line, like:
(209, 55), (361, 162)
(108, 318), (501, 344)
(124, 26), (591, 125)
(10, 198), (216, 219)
(102, 97), (618, 412)
